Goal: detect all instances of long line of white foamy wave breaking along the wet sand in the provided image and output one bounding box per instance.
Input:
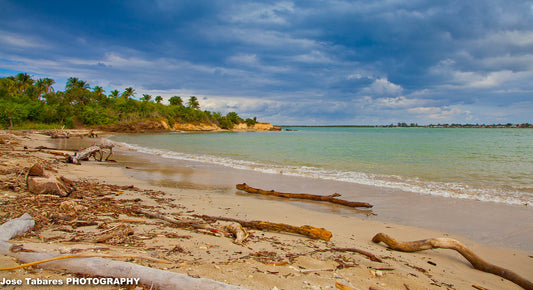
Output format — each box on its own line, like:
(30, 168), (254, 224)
(112, 141), (533, 205)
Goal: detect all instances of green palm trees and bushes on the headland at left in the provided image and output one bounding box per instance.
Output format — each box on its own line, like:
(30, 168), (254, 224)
(0, 73), (256, 129)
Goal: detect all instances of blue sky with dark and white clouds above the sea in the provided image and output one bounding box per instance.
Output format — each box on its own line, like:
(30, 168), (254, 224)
(0, 0), (533, 124)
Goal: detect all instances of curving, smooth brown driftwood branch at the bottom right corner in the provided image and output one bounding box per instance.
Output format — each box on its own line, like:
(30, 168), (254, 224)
(372, 233), (533, 290)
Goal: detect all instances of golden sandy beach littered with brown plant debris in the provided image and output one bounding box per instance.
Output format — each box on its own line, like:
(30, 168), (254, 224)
(0, 131), (533, 289)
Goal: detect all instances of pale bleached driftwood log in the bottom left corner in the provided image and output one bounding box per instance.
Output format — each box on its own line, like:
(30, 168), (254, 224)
(0, 214), (243, 289)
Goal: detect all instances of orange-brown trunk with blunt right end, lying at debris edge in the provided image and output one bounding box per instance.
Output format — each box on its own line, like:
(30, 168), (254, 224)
(194, 215), (332, 241)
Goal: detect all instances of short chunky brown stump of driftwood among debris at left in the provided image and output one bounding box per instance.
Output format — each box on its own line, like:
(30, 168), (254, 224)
(26, 164), (75, 197)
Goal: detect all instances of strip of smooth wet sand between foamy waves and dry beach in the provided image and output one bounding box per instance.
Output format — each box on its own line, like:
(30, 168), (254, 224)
(101, 131), (533, 253)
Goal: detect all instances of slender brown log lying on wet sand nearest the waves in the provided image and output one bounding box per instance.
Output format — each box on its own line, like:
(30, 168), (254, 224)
(236, 183), (372, 208)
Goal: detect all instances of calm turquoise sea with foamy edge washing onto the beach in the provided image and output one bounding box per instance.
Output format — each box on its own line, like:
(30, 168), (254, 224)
(110, 127), (533, 204)
